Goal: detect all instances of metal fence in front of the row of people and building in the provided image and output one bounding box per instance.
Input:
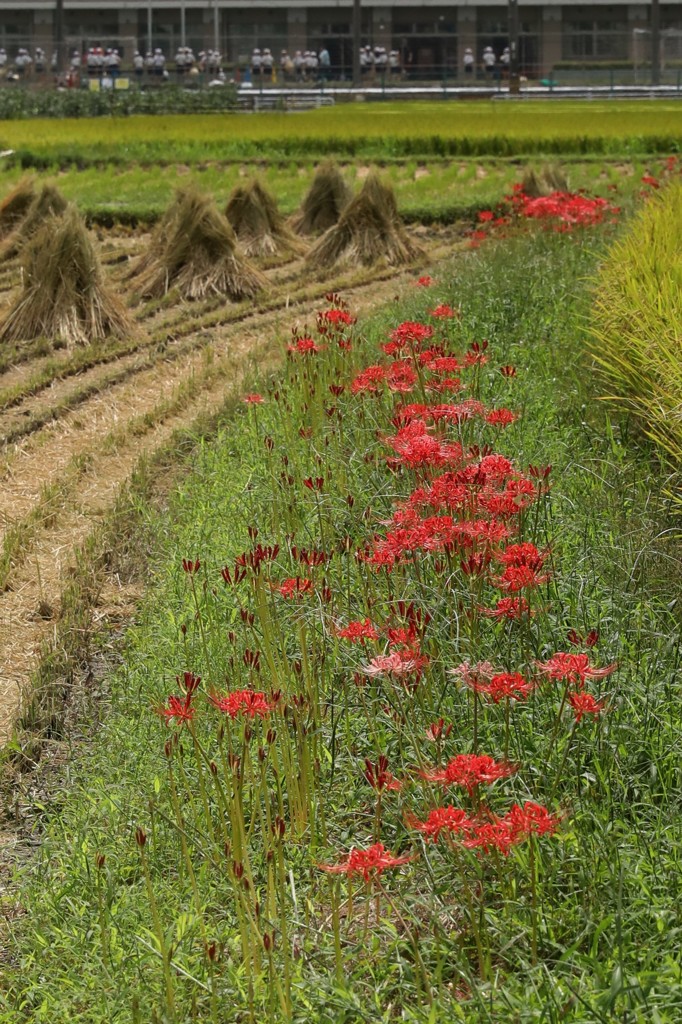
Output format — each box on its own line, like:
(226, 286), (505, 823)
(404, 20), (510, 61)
(0, 27), (682, 91)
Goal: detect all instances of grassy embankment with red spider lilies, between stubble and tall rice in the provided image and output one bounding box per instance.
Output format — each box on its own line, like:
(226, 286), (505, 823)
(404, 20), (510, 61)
(0, 226), (682, 1024)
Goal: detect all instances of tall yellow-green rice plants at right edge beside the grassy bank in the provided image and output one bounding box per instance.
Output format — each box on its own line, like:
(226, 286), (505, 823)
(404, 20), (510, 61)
(590, 181), (682, 495)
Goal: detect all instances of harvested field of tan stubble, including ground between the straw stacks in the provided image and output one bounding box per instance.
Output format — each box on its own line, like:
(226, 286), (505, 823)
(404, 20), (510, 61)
(0, 186), (468, 740)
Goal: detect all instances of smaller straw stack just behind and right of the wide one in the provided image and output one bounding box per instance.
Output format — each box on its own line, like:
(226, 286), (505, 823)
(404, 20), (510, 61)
(225, 181), (304, 257)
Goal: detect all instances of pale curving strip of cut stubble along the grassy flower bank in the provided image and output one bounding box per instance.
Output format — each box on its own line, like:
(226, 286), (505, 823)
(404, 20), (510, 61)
(0, 232), (462, 743)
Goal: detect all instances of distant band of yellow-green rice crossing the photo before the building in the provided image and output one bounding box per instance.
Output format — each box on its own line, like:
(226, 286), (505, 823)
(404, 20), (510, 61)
(0, 100), (682, 166)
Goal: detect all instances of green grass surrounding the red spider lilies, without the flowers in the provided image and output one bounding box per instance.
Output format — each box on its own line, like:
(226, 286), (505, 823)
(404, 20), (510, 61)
(0, 226), (682, 1024)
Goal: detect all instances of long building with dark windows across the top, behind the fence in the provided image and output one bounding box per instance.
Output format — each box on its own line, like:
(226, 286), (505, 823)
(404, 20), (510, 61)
(0, 0), (682, 77)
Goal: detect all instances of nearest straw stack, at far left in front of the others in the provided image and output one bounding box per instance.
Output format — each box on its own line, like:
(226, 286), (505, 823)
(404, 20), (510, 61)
(0, 207), (132, 344)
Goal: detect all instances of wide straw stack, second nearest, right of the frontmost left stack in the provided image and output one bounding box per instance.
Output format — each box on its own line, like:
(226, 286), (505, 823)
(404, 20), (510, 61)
(131, 190), (267, 300)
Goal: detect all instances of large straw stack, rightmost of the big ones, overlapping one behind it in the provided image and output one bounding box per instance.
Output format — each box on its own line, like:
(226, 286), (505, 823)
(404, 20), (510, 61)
(306, 173), (423, 267)
